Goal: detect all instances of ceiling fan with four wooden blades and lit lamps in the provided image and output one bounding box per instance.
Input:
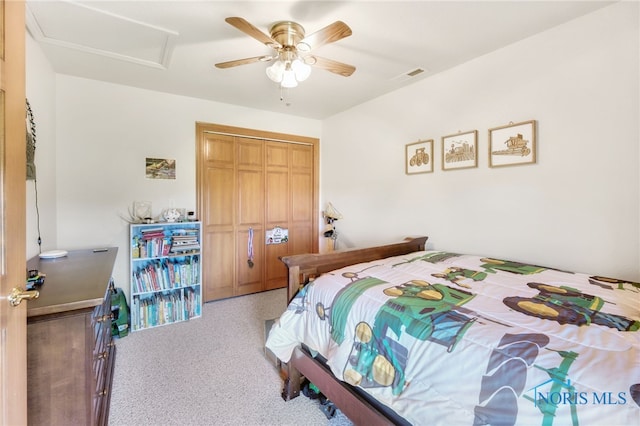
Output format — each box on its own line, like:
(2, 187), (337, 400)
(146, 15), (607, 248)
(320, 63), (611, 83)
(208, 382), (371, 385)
(216, 17), (356, 87)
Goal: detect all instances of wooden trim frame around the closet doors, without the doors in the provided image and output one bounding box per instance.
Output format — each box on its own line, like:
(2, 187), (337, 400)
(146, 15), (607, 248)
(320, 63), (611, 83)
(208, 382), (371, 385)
(196, 122), (321, 298)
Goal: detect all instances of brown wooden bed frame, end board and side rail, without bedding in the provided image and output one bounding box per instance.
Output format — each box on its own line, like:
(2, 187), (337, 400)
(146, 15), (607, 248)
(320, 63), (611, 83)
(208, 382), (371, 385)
(281, 237), (428, 426)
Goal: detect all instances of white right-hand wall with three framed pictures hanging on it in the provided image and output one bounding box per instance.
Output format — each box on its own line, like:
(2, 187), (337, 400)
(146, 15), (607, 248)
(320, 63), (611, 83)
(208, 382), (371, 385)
(321, 2), (640, 281)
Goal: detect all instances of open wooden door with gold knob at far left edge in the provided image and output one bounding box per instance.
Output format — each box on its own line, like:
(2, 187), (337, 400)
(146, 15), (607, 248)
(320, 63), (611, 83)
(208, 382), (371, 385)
(0, 0), (28, 425)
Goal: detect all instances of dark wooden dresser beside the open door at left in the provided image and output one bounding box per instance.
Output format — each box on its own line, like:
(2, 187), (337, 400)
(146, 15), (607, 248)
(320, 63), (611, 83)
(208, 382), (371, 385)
(27, 247), (118, 425)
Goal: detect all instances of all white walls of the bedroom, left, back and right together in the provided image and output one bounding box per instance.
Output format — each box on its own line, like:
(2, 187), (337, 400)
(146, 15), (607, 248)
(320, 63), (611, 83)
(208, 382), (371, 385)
(27, 2), (640, 300)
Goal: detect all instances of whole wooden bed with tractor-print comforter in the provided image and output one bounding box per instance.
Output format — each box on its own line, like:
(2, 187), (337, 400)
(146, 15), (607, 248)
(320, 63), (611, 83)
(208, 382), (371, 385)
(266, 237), (640, 426)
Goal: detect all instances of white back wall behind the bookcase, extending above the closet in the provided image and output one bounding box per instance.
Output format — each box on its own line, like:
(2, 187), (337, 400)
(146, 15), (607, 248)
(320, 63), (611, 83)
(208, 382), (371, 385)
(50, 75), (321, 294)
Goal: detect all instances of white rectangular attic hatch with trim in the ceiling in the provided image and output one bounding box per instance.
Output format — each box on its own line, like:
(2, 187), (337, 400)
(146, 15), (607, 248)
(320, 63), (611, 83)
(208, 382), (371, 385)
(26, 1), (178, 69)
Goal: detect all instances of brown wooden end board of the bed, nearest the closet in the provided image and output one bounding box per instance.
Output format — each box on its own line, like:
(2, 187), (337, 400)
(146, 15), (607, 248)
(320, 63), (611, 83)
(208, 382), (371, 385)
(280, 237), (428, 302)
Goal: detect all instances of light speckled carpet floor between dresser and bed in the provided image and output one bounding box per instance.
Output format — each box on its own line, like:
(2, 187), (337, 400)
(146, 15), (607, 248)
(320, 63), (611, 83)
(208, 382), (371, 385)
(109, 289), (351, 426)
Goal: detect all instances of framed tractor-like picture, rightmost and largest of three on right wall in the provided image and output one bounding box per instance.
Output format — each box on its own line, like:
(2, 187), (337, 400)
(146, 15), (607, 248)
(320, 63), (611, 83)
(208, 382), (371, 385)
(489, 120), (536, 167)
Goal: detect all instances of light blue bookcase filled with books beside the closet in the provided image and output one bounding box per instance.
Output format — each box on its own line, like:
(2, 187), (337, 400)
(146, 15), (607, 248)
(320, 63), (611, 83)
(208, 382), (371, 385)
(129, 222), (202, 331)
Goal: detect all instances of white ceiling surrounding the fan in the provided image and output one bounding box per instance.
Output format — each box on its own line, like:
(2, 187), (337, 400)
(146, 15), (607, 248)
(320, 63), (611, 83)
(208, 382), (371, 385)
(27, 0), (613, 119)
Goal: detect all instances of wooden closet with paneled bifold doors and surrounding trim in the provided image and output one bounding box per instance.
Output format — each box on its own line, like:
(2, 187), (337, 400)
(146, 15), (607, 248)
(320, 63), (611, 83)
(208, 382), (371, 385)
(196, 123), (319, 301)
